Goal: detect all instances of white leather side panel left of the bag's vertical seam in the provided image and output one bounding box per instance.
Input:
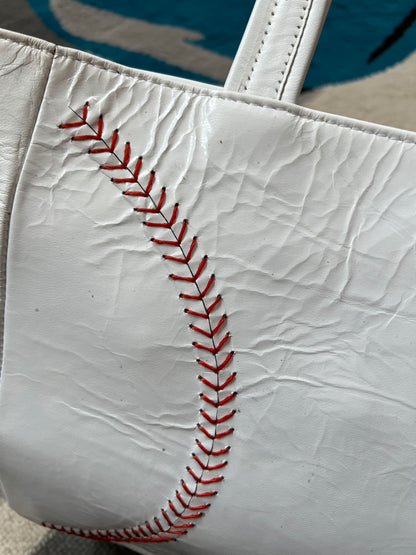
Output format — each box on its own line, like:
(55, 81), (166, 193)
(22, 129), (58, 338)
(0, 31), (53, 372)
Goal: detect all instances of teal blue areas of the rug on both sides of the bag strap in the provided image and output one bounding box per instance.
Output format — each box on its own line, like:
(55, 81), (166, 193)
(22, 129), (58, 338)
(29, 0), (416, 88)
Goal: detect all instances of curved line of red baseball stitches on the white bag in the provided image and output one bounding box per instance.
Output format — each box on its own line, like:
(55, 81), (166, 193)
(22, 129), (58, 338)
(48, 102), (237, 542)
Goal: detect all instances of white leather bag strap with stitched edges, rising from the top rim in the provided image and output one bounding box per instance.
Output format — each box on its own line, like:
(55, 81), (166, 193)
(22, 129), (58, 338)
(225, 0), (331, 102)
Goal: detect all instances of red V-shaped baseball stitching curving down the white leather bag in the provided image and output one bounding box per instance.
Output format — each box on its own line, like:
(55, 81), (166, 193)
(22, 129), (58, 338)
(42, 102), (237, 542)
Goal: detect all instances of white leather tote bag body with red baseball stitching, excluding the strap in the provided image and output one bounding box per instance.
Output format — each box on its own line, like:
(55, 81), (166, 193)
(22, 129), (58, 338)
(0, 0), (416, 555)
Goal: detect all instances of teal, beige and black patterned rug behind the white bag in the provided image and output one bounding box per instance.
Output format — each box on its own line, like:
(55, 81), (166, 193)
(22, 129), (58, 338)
(0, 0), (416, 555)
